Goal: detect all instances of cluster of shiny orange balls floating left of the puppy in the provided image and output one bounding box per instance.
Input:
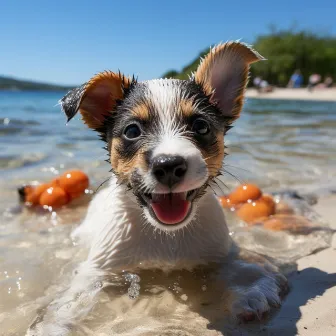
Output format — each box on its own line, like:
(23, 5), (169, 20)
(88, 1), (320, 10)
(18, 170), (89, 208)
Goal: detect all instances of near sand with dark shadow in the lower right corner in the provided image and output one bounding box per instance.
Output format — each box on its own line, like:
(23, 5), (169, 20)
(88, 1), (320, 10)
(260, 196), (336, 336)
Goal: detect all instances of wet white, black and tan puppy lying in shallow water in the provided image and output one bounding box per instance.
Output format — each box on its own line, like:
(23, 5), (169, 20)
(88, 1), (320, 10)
(27, 42), (287, 335)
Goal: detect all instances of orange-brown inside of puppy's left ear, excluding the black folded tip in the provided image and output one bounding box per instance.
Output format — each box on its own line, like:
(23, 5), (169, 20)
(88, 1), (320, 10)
(79, 71), (131, 129)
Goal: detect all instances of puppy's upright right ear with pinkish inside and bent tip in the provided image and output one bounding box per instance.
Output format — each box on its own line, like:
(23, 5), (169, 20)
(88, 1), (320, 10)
(194, 42), (264, 121)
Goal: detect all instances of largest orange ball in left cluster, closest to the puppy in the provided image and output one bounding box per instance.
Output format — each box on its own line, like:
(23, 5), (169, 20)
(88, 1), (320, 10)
(55, 170), (89, 198)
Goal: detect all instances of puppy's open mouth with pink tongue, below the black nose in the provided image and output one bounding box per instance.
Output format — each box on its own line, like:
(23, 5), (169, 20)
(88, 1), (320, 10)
(141, 189), (197, 225)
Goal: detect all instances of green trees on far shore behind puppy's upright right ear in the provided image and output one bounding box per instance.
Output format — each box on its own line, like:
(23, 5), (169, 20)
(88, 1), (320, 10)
(163, 28), (336, 86)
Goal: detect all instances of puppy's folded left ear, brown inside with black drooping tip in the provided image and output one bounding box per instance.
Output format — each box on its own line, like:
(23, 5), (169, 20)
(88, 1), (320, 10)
(60, 71), (131, 130)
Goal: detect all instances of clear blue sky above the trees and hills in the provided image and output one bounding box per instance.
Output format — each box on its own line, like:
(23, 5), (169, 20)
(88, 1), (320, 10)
(0, 0), (336, 84)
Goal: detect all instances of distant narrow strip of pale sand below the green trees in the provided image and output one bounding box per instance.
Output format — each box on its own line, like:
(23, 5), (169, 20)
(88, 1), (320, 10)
(246, 88), (336, 101)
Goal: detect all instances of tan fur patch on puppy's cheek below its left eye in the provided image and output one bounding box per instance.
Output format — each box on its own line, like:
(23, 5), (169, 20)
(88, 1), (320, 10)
(110, 138), (148, 181)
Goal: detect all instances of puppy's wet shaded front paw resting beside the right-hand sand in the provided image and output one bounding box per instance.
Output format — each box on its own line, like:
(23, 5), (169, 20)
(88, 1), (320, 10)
(231, 273), (288, 322)
